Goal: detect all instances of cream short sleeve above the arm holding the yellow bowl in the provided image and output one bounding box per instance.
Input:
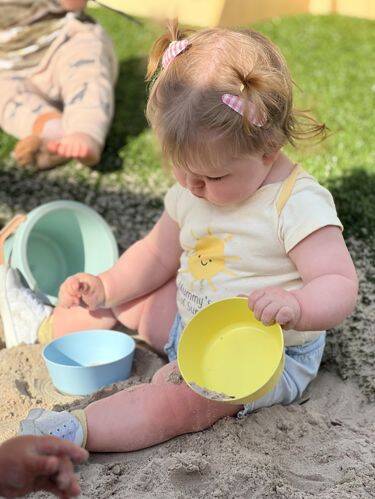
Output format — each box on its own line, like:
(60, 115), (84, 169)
(279, 178), (343, 253)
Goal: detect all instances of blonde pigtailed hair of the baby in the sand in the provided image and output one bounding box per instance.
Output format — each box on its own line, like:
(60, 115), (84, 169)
(146, 21), (325, 172)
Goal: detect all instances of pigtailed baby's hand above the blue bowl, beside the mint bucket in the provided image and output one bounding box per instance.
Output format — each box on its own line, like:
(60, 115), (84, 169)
(59, 273), (105, 311)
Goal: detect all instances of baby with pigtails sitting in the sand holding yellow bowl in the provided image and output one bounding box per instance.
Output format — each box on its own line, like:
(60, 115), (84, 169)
(5, 21), (358, 452)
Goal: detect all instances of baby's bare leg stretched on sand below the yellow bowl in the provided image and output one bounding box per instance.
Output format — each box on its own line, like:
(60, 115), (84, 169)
(85, 363), (242, 452)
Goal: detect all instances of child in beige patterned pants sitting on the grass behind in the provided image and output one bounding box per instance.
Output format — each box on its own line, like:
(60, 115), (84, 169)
(0, 0), (117, 169)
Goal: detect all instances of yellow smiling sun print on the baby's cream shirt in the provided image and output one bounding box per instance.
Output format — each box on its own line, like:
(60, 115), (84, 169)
(180, 228), (240, 291)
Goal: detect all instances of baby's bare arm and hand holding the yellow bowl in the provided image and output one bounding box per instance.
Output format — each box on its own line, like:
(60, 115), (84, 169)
(249, 226), (358, 331)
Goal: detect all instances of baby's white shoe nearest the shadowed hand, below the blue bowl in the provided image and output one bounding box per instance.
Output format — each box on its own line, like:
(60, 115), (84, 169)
(19, 409), (84, 446)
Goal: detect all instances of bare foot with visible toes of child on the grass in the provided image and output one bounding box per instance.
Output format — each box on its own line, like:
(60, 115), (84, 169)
(47, 132), (102, 166)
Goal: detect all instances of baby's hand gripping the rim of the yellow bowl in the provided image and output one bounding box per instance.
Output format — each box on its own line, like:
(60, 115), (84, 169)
(249, 288), (301, 329)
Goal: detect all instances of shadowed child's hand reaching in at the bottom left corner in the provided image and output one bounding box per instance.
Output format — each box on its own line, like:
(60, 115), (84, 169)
(0, 436), (88, 498)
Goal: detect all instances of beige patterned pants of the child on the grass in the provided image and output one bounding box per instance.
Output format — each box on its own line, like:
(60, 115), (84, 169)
(0, 19), (118, 145)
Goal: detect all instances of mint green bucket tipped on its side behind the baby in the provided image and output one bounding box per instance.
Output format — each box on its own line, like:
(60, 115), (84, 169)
(4, 201), (119, 305)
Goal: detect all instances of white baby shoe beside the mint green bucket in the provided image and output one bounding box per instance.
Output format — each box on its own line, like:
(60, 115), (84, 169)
(0, 264), (52, 348)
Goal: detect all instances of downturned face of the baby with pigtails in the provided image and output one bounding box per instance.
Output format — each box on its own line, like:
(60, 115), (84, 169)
(173, 154), (270, 206)
